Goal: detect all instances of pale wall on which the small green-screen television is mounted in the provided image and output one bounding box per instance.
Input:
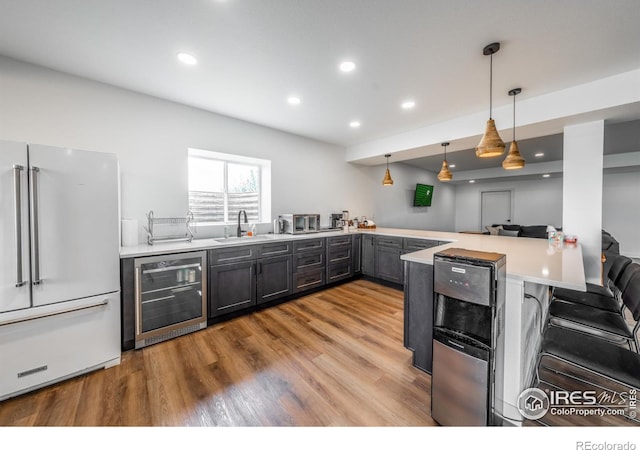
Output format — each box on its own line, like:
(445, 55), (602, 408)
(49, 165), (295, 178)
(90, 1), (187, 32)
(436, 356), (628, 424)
(367, 163), (456, 231)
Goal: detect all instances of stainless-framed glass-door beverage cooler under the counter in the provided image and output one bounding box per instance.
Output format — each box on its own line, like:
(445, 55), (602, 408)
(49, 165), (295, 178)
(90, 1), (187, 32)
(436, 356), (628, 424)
(135, 251), (207, 348)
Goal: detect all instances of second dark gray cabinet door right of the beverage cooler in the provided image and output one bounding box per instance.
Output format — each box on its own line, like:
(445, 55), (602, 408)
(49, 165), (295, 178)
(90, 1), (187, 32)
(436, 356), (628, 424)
(257, 255), (292, 304)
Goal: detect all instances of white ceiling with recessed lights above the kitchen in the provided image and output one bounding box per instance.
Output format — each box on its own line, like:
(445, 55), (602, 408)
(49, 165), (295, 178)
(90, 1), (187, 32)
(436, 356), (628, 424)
(0, 0), (640, 169)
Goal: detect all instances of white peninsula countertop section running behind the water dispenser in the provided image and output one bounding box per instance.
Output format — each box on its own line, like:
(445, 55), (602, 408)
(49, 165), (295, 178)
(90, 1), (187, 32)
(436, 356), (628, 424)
(362, 228), (586, 291)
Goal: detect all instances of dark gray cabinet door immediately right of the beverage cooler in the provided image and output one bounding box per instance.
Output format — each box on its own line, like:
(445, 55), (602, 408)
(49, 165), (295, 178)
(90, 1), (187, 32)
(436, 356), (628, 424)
(209, 261), (256, 317)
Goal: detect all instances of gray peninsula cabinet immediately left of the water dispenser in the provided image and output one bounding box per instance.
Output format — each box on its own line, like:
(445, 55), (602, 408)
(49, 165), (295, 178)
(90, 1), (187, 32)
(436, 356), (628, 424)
(404, 261), (433, 373)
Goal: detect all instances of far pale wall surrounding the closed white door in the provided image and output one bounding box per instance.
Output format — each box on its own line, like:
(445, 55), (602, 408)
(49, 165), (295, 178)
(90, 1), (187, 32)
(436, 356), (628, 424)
(455, 178), (562, 231)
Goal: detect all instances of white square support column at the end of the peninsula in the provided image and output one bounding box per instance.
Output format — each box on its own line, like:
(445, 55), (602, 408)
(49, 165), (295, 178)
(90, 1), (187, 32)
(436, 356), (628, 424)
(562, 120), (604, 284)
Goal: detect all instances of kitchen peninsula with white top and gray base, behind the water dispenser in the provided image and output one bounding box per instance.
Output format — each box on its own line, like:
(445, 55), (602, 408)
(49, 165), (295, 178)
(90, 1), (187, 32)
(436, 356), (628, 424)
(376, 229), (586, 425)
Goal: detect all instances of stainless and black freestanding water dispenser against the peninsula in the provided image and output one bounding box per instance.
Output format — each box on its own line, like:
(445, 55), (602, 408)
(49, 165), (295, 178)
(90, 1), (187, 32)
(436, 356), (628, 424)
(431, 248), (506, 426)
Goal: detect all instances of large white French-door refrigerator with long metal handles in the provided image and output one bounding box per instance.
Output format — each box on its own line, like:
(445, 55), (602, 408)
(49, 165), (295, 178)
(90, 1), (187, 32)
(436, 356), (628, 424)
(0, 141), (120, 400)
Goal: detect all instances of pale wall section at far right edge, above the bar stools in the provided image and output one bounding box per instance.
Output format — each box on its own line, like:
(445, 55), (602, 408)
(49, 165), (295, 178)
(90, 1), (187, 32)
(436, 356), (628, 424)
(602, 171), (640, 258)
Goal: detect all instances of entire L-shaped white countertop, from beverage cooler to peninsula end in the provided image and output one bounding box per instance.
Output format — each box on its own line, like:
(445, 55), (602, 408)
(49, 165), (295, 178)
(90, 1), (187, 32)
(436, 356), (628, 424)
(120, 228), (586, 291)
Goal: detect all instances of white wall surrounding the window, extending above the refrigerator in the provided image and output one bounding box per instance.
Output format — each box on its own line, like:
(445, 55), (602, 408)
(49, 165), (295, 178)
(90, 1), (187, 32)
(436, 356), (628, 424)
(0, 57), (374, 243)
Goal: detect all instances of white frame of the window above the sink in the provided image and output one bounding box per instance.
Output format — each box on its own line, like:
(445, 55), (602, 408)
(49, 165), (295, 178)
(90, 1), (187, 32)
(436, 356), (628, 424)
(187, 148), (271, 225)
